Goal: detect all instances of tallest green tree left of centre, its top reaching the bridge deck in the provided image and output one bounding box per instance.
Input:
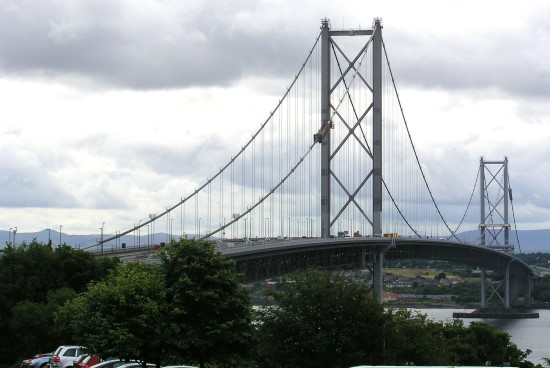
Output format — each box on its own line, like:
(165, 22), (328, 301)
(160, 239), (252, 367)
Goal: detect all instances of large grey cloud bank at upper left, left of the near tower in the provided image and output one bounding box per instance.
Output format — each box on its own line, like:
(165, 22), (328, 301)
(0, 1), (315, 89)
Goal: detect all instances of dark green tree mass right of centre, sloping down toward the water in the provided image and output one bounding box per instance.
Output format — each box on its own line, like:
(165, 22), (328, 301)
(258, 271), (532, 368)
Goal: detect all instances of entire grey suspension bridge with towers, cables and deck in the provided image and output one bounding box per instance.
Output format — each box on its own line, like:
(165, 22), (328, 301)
(87, 19), (532, 307)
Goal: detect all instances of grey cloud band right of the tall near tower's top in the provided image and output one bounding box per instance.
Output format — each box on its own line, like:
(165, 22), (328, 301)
(386, 18), (550, 98)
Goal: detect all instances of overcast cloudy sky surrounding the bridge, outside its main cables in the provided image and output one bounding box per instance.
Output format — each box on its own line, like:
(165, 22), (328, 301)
(0, 0), (550, 234)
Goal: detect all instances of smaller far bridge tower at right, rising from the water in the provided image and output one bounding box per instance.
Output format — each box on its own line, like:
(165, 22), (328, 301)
(479, 157), (514, 308)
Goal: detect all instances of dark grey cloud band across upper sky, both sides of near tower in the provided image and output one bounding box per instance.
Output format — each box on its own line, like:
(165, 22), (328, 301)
(0, 0), (550, 97)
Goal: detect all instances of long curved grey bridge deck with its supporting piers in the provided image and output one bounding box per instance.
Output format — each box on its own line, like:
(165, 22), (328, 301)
(97, 237), (534, 307)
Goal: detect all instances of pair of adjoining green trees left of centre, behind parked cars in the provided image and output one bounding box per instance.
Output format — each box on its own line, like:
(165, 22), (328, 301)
(56, 239), (252, 366)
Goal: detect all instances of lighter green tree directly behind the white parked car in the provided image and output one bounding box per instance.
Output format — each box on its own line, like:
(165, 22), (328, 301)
(55, 263), (168, 367)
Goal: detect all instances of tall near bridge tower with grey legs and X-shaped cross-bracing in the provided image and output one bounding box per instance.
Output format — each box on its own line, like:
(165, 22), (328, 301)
(320, 19), (387, 302)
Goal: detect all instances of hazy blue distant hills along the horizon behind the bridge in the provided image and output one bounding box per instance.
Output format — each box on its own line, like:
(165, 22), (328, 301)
(0, 229), (550, 253)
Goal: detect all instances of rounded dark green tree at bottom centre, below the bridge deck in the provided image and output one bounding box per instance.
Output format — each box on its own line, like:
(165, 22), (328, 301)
(258, 270), (386, 367)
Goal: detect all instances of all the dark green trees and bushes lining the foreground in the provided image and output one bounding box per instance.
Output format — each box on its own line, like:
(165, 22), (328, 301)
(0, 239), (548, 368)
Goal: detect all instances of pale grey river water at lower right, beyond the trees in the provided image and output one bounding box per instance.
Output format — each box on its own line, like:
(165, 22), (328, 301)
(420, 308), (550, 365)
